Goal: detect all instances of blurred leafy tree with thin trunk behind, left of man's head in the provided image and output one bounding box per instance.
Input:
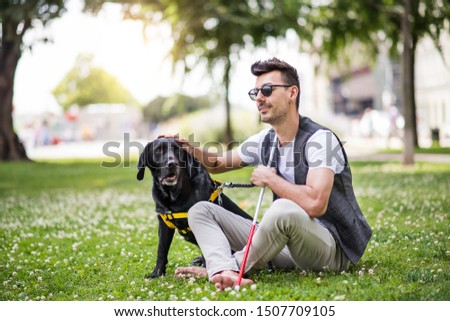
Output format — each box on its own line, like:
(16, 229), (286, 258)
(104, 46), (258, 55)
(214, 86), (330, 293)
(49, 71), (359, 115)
(119, 0), (298, 146)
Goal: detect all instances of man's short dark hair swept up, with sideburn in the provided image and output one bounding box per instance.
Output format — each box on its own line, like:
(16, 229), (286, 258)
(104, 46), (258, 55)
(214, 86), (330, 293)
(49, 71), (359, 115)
(251, 58), (300, 108)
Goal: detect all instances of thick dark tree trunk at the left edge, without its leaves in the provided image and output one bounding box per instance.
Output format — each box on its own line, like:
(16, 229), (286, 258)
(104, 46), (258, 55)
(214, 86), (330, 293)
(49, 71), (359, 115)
(0, 26), (28, 162)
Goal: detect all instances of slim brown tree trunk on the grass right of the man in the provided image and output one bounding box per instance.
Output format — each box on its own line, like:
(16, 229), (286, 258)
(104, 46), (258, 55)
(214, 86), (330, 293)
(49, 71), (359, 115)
(401, 0), (415, 165)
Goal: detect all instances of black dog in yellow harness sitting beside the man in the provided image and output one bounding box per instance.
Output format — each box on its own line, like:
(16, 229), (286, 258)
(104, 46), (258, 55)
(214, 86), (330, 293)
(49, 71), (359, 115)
(137, 138), (252, 278)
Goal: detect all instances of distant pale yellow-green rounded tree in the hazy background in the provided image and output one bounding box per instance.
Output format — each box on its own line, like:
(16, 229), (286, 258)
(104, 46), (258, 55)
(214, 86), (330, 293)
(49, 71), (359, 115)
(53, 55), (137, 110)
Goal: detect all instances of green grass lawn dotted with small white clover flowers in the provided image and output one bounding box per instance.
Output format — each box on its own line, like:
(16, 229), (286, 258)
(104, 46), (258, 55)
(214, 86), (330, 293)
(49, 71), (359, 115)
(0, 161), (450, 301)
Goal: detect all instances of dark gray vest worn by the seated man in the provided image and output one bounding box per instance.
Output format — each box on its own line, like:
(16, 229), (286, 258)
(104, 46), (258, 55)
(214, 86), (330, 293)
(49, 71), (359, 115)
(261, 116), (372, 264)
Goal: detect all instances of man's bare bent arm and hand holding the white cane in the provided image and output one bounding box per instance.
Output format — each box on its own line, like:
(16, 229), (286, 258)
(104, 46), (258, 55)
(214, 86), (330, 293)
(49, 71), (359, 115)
(250, 166), (334, 217)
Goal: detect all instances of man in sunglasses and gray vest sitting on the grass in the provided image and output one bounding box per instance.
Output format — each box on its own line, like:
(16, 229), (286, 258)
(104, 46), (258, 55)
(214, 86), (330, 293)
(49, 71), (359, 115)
(167, 58), (372, 290)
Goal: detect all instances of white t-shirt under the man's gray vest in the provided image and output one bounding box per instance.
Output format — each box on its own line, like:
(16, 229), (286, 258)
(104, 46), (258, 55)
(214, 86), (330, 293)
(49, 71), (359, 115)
(237, 129), (345, 183)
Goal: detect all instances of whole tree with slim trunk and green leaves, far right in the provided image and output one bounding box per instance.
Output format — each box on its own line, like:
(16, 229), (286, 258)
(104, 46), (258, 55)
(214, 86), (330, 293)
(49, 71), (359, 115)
(301, 0), (450, 164)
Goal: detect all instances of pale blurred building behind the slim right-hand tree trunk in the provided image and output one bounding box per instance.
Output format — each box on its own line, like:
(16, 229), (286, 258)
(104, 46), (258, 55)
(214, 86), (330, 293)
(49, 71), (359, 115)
(331, 35), (450, 143)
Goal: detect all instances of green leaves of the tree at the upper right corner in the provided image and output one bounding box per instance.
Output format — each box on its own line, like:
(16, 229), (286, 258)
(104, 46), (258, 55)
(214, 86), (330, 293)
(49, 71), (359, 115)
(303, 0), (450, 63)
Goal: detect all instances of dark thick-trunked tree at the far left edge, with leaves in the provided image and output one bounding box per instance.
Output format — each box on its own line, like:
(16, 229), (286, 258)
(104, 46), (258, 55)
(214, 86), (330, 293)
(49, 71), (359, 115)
(0, 0), (65, 161)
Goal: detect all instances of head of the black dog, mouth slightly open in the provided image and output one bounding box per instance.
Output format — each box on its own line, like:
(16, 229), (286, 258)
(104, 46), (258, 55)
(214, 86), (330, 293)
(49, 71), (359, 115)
(137, 138), (201, 187)
